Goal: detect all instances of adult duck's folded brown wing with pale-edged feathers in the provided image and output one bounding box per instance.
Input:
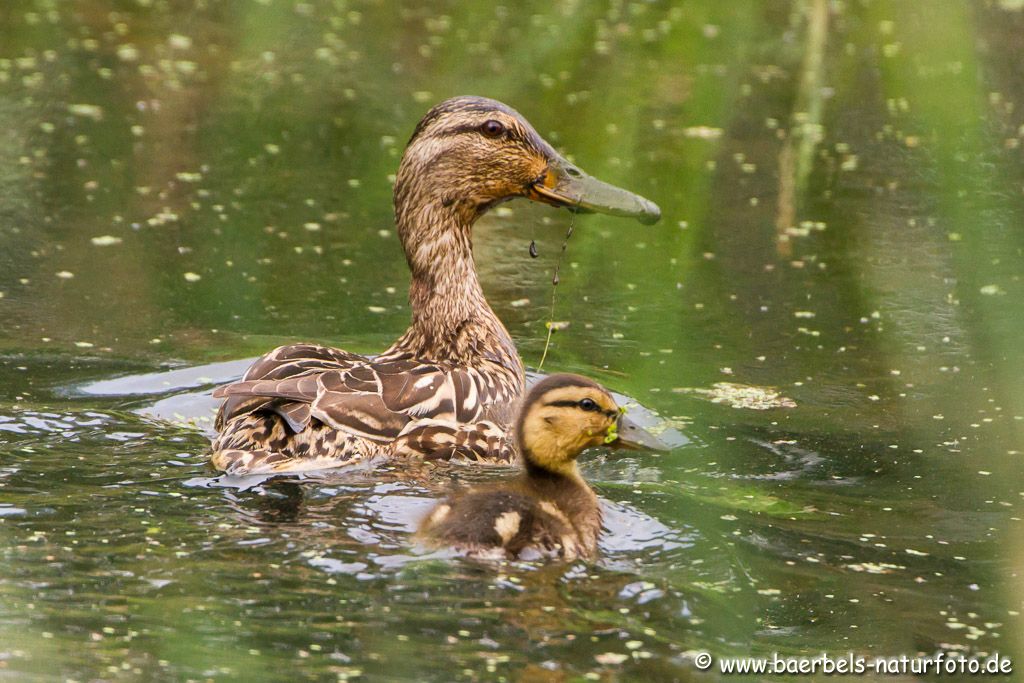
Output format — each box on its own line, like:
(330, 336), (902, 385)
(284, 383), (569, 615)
(214, 345), (520, 442)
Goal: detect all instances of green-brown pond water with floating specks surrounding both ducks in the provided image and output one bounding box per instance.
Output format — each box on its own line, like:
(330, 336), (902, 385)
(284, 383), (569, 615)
(0, 0), (1024, 681)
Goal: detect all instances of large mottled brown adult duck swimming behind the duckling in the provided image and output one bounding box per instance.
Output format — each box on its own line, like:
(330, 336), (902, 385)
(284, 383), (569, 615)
(212, 97), (659, 474)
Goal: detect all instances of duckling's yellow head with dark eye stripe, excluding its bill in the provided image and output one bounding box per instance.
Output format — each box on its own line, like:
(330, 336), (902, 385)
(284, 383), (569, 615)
(516, 375), (622, 475)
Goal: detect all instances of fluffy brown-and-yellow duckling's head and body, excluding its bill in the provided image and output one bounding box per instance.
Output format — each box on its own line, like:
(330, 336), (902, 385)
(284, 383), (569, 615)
(418, 374), (623, 560)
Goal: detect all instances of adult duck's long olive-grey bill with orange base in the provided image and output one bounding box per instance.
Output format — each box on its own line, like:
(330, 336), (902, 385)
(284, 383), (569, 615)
(526, 157), (662, 225)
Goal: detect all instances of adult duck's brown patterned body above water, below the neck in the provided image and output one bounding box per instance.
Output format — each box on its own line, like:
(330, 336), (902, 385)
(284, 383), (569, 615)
(214, 344), (517, 473)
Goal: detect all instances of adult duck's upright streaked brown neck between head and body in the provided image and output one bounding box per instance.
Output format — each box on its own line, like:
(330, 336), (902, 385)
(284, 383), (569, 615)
(391, 187), (522, 377)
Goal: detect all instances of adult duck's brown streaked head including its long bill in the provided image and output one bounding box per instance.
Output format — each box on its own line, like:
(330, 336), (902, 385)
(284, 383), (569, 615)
(395, 96), (660, 223)
